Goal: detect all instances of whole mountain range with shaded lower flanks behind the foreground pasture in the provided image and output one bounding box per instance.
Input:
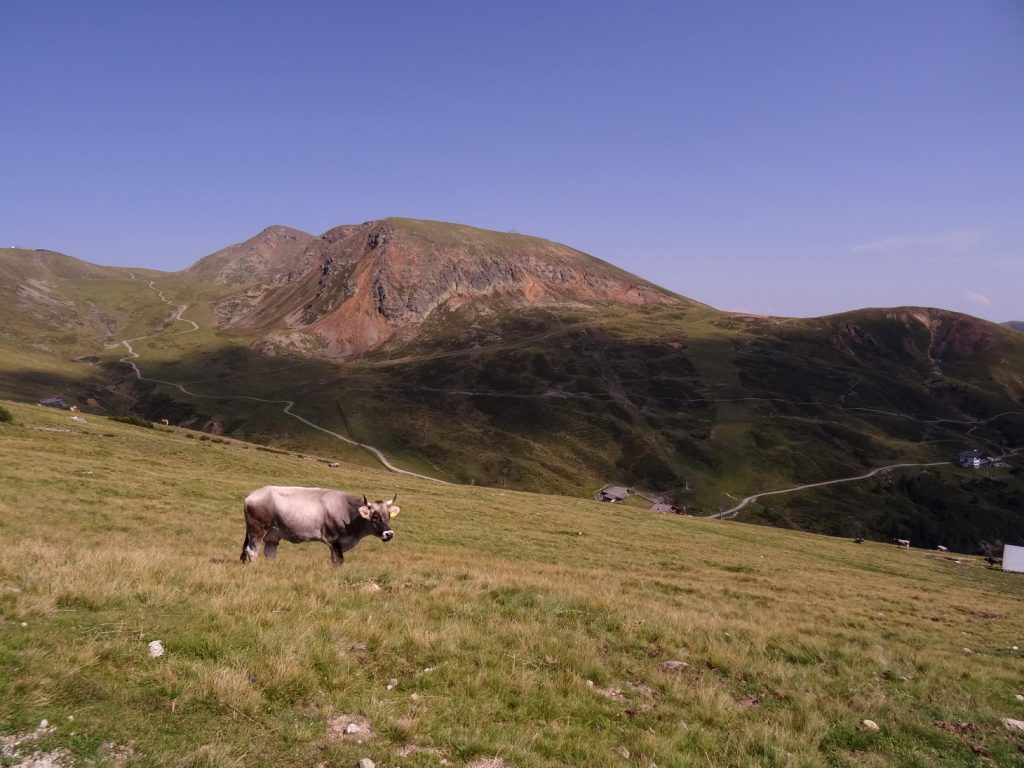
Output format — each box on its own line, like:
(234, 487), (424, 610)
(0, 218), (1024, 550)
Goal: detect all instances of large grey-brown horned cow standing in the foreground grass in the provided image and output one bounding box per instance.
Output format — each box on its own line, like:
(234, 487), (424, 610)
(242, 485), (399, 565)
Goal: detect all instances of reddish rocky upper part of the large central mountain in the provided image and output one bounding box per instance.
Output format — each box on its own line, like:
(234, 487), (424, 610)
(211, 219), (686, 357)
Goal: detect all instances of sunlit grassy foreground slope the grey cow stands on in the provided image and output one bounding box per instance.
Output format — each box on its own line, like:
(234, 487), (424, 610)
(0, 403), (1024, 768)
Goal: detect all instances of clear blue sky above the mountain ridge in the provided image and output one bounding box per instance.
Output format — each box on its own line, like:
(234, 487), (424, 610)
(0, 0), (1024, 321)
